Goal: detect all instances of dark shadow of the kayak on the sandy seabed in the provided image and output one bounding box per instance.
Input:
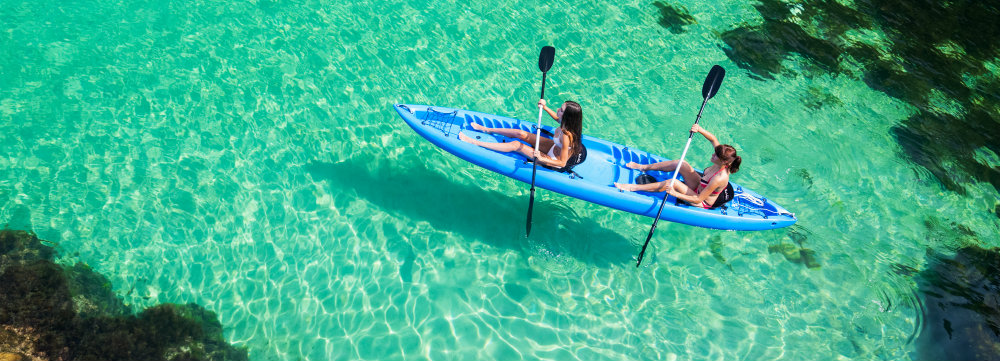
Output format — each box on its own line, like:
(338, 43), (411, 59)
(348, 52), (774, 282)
(305, 160), (635, 267)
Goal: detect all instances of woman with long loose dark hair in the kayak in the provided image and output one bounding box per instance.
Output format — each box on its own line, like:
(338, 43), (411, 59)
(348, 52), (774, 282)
(458, 99), (583, 168)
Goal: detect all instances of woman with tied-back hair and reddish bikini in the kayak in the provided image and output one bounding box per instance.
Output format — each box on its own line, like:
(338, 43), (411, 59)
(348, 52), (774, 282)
(615, 124), (743, 209)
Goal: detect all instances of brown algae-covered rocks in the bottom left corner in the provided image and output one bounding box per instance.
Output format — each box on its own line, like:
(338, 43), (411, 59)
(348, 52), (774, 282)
(0, 230), (248, 360)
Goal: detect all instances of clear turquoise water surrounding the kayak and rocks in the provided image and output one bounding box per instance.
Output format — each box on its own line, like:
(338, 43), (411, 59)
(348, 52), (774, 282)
(0, 0), (1000, 360)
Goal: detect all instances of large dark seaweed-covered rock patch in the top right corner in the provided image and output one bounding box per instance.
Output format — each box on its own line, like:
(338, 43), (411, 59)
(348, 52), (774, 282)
(721, 0), (1000, 197)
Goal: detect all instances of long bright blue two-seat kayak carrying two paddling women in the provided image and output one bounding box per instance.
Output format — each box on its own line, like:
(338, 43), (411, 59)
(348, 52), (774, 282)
(395, 104), (796, 231)
